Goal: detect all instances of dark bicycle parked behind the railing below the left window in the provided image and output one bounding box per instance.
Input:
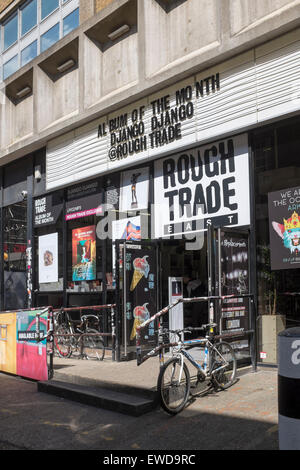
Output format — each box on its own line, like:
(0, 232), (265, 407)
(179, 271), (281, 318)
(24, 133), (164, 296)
(54, 311), (105, 361)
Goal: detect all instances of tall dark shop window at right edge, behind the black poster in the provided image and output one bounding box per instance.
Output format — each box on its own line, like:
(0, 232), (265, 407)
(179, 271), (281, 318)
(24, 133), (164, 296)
(253, 120), (300, 327)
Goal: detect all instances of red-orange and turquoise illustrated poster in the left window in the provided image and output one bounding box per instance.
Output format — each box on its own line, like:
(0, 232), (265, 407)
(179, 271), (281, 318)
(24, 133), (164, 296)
(72, 225), (96, 281)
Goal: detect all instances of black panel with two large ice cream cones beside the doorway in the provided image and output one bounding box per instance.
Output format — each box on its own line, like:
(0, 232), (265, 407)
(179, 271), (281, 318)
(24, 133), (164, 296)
(125, 246), (157, 347)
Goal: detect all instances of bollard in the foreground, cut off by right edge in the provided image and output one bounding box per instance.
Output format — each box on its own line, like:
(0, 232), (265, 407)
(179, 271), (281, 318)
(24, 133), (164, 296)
(278, 328), (300, 450)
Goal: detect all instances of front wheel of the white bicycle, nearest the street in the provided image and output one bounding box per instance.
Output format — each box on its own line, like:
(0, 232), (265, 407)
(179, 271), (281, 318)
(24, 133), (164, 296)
(157, 357), (190, 415)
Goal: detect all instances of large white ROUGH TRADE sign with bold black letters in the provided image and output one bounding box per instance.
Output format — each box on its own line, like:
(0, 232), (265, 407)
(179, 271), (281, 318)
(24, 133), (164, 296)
(155, 134), (250, 238)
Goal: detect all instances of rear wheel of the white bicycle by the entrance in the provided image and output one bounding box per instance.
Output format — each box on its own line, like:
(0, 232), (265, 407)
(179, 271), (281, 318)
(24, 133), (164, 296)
(211, 342), (236, 390)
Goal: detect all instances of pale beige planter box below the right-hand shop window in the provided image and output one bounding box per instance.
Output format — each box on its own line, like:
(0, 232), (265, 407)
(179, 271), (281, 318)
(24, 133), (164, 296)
(257, 315), (286, 364)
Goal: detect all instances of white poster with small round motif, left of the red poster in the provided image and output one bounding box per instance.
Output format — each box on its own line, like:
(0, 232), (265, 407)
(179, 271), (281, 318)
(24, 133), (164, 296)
(39, 233), (58, 284)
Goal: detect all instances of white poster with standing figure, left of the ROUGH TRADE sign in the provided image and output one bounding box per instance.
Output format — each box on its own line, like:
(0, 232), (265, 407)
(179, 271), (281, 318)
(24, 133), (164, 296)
(120, 167), (149, 212)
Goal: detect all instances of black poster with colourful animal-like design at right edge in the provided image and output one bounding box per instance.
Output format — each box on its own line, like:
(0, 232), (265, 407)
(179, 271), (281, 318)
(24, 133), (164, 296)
(268, 186), (300, 270)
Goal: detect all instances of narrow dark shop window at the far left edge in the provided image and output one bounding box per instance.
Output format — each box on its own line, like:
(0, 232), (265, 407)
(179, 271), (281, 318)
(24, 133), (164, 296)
(3, 201), (27, 310)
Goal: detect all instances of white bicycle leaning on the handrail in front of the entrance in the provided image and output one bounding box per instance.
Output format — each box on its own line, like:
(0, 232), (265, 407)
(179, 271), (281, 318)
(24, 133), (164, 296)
(157, 323), (237, 415)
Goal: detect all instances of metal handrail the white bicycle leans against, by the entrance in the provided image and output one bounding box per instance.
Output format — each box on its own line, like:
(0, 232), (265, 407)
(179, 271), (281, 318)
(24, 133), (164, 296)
(136, 294), (255, 368)
